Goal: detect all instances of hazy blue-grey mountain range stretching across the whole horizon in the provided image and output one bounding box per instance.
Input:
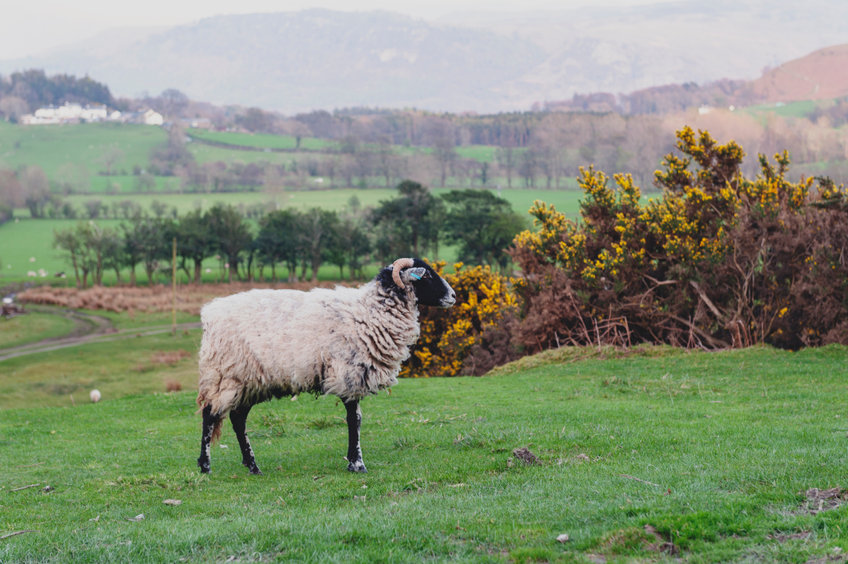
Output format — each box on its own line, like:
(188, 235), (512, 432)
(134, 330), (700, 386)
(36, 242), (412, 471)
(0, 0), (848, 114)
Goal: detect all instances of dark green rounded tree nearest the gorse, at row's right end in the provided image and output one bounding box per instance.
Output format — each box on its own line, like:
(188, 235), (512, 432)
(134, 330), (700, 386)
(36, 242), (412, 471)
(442, 190), (524, 269)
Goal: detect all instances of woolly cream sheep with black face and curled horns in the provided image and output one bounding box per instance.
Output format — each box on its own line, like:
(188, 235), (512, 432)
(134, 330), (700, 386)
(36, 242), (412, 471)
(197, 258), (456, 474)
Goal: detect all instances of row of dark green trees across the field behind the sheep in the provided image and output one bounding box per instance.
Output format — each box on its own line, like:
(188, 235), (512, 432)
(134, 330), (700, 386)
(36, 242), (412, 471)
(54, 181), (525, 288)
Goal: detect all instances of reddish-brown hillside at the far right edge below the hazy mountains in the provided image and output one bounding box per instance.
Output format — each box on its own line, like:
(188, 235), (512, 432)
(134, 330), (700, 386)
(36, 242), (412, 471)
(751, 44), (848, 102)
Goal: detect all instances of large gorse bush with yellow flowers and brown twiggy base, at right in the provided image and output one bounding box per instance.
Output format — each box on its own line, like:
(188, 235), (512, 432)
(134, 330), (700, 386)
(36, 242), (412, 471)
(511, 128), (848, 350)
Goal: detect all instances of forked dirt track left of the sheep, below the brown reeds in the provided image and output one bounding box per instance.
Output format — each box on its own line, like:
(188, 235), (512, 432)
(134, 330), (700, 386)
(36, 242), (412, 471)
(0, 306), (200, 362)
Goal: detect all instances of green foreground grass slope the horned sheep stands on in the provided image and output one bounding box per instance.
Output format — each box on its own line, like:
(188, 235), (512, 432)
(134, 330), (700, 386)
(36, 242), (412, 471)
(0, 342), (848, 562)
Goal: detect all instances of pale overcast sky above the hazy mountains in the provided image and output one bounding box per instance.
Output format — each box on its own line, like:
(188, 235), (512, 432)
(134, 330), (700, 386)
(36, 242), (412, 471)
(0, 0), (669, 59)
